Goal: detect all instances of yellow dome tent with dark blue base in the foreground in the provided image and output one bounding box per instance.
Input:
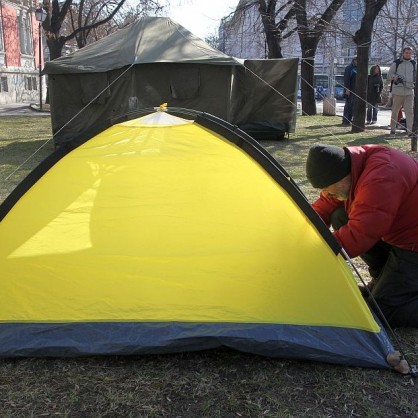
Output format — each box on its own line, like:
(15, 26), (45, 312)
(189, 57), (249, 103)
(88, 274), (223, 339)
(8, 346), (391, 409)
(0, 111), (393, 368)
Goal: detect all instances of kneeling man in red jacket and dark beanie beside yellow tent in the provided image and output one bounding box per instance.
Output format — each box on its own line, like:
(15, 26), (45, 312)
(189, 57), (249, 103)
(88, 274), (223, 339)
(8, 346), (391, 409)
(306, 144), (418, 327)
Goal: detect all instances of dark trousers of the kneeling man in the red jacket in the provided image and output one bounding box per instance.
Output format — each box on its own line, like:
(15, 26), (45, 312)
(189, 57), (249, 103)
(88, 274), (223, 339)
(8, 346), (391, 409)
(331, 208), (418, 328)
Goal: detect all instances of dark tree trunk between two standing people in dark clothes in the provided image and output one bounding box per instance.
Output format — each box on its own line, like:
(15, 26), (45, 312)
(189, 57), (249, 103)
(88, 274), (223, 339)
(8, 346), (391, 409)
(352, 0), (387, 132)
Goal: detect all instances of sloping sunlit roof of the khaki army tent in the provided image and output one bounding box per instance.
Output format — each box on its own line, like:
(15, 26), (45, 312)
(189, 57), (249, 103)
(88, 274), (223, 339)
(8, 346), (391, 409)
(45, 17), (240, 74)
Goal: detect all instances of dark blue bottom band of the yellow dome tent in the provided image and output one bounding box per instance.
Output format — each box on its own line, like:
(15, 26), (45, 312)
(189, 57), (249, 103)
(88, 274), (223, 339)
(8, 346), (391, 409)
(0, 322), (394, 368)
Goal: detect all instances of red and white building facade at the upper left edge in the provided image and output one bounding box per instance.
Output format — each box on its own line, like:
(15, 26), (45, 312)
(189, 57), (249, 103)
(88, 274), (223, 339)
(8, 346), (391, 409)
(0, 0), (45, 104)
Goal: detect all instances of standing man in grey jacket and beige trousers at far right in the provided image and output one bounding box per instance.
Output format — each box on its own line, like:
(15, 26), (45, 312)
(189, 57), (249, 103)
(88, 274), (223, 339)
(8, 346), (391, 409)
(388, 46), (416, 135)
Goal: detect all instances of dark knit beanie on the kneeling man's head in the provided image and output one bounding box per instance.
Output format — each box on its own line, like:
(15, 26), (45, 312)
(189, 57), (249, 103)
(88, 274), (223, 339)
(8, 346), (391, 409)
(306, 144), (351, 189)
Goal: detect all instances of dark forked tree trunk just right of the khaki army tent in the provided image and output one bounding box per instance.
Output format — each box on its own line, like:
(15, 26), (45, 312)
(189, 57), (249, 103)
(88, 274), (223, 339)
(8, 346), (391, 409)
(295, 0), (345, 115)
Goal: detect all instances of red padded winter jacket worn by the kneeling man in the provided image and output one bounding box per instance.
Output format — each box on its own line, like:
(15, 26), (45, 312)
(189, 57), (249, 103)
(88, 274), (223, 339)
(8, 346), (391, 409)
(312, 145), (418, 257)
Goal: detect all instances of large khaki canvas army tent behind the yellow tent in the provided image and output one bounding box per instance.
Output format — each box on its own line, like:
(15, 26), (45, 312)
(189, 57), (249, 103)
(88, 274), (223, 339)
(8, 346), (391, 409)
(44, 17), (298, 142)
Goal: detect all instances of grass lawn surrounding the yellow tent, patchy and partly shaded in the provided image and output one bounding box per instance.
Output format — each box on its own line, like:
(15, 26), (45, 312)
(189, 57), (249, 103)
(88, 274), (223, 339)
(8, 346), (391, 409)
(0, 112), (418, 418)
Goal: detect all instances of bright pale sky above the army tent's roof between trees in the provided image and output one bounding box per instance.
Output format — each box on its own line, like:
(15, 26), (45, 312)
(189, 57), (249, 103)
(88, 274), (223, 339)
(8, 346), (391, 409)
(167, 0), (239, 39)
